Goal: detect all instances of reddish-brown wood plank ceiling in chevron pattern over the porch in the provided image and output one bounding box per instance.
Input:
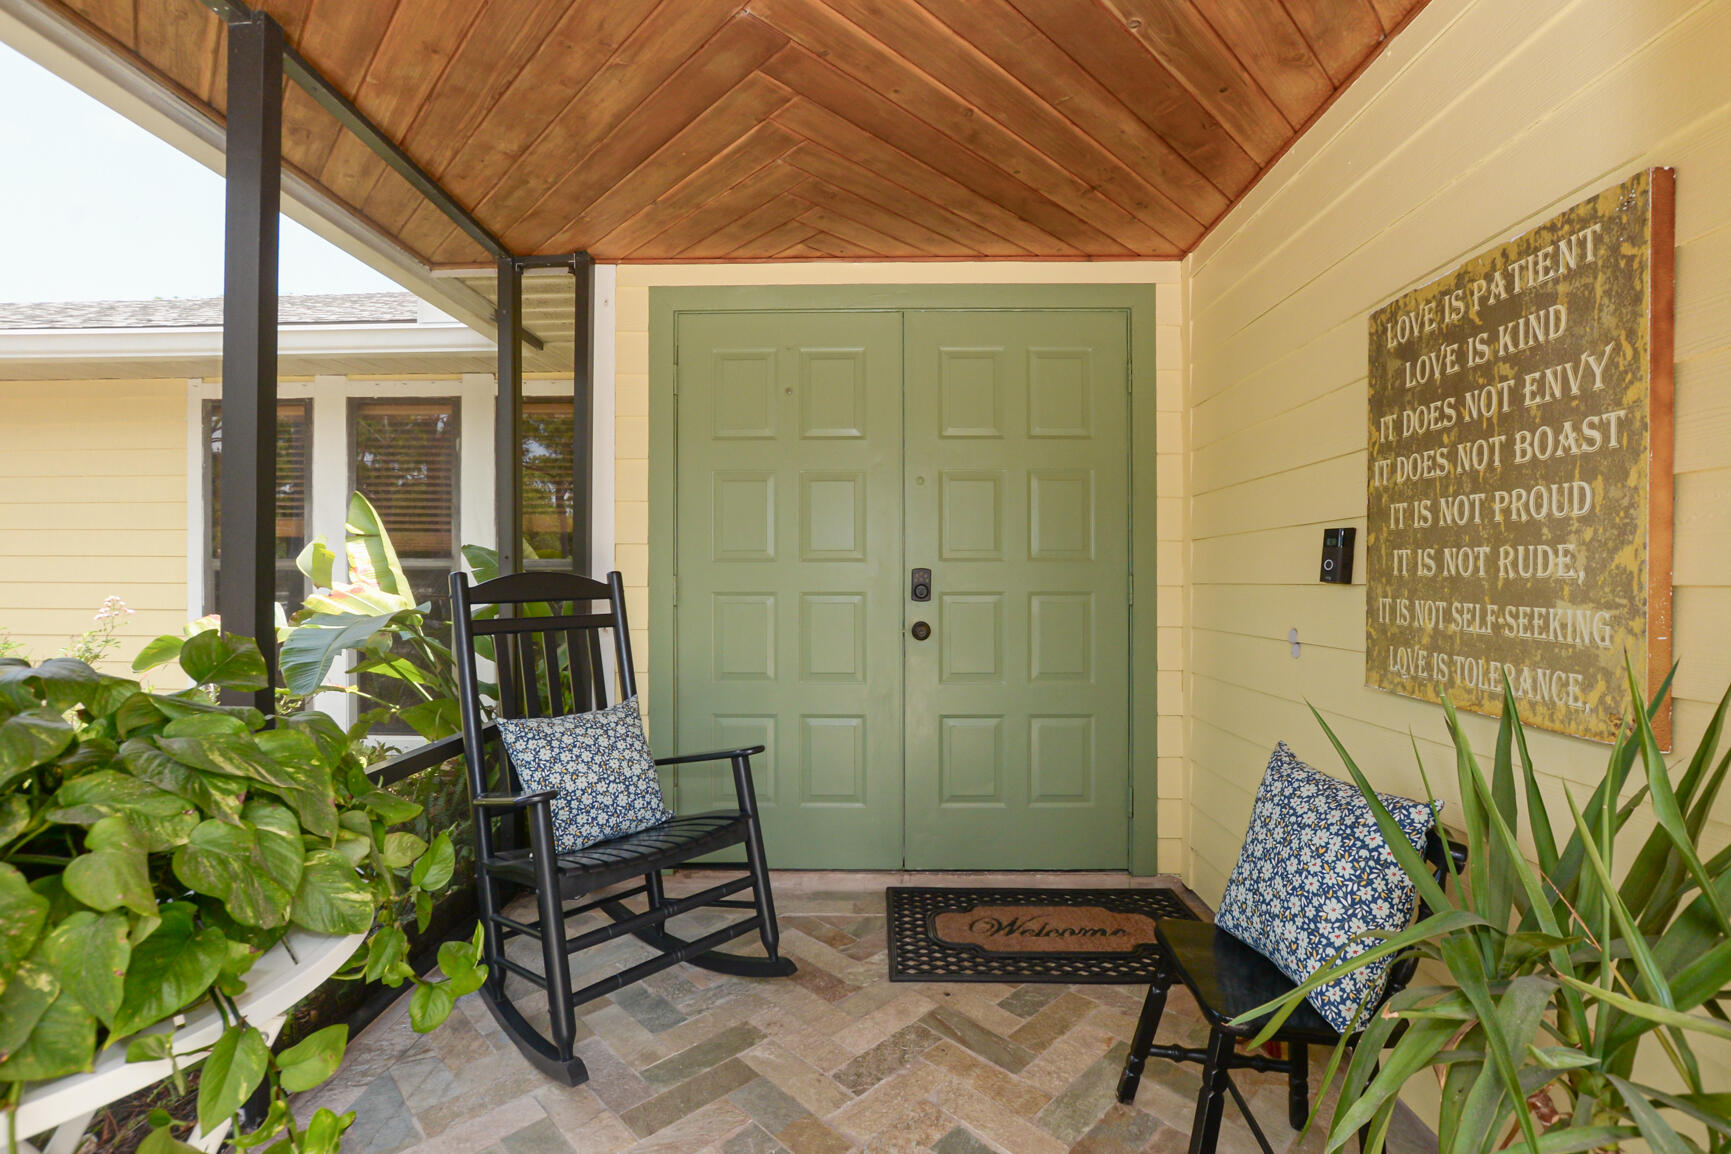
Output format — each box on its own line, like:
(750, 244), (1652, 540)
(57, 0), (1423, 266)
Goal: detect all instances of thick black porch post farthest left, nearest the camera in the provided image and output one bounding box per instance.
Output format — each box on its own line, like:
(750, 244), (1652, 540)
(216, 16), (282, 713)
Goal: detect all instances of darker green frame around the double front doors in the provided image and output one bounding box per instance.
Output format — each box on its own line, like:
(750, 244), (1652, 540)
(647, 284), (1160, 875)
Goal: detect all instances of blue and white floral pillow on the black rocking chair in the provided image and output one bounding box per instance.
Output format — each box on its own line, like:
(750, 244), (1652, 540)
(499, 697), (673, 853)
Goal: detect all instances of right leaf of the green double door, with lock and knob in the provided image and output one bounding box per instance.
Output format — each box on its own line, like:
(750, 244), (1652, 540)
(904, 311), (1130, 869)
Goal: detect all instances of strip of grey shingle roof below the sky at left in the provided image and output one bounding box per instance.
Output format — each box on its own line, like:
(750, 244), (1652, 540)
(0, 292), (421, 329)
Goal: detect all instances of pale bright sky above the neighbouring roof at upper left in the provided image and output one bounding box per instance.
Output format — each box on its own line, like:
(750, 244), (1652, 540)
(0, 43), (402, 301)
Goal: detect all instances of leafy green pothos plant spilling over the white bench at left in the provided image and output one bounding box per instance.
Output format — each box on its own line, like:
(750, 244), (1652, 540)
(0, 631), (486, 1154)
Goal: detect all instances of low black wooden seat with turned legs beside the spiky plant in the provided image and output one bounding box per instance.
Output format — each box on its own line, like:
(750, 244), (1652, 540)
(1118, 829), (1466, 1154)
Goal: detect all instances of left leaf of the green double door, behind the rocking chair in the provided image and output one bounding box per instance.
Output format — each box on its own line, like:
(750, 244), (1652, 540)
(673, 311), (902, 869)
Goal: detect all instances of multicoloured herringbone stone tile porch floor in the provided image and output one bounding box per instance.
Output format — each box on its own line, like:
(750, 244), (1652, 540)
(296, 872), (1364, 1154)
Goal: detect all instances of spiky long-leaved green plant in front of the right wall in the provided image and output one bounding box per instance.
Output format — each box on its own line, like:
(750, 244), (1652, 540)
(1239, 671), (1731, 1154)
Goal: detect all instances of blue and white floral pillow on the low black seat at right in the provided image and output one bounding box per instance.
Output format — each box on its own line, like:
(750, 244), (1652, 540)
(1213, 742), (1440, 1033)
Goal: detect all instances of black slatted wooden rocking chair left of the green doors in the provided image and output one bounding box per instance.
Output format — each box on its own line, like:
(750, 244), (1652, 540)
(450, 573), (795, 1087)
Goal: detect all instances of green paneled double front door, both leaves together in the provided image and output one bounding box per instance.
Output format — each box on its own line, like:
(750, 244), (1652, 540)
(658, 310), (1130, 869)
